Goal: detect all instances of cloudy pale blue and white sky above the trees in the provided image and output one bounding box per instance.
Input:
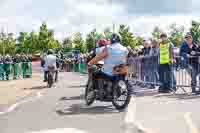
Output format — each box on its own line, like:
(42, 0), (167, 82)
(0, 0), (200, 39)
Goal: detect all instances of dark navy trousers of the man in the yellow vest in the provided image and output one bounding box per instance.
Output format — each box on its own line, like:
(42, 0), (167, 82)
(159, 64), (171, 90)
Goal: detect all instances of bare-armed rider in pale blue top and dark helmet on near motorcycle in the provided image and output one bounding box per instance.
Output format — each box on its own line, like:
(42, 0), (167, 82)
(88, 33), (129, 84)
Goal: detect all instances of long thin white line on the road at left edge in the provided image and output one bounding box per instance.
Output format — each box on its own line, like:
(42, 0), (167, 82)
(0, 92), (42, 115)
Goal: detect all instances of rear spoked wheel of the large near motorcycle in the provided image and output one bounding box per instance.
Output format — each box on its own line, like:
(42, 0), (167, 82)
(112, 80), (131, 110)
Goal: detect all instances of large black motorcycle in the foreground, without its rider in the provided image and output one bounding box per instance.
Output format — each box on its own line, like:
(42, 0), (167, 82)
(85, 65), (131, 110)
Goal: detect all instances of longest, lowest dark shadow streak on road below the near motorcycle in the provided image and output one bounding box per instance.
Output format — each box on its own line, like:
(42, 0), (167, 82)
(56, 104), (119, 115)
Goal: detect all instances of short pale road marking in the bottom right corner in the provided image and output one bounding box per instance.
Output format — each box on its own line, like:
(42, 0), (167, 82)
(184, 112), (200, 133)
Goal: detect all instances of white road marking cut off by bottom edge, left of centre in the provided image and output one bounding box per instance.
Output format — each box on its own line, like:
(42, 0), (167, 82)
(28, 128), (88, 133)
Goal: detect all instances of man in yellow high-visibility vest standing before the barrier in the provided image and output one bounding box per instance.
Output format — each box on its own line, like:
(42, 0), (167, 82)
(159, 33), (173, 93)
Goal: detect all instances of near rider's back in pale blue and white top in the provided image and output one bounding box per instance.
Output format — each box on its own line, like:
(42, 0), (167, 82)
(103, 43), (128, 75)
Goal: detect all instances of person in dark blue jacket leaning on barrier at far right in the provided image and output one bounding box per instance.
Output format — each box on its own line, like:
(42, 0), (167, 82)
(180, 34), (200, 94)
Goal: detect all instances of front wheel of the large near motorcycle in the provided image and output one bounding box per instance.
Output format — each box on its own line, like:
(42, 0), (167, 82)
(85, 79), (96, 106)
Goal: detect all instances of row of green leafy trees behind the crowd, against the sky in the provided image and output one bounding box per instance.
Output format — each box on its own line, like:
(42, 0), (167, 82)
(0, 21), (200, 55)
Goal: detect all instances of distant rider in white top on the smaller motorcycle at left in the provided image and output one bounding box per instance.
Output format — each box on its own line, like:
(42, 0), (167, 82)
(44, 49), (58, 82)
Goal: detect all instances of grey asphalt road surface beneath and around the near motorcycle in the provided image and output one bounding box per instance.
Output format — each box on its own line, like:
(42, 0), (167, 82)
(0, 73), (200, 133)
